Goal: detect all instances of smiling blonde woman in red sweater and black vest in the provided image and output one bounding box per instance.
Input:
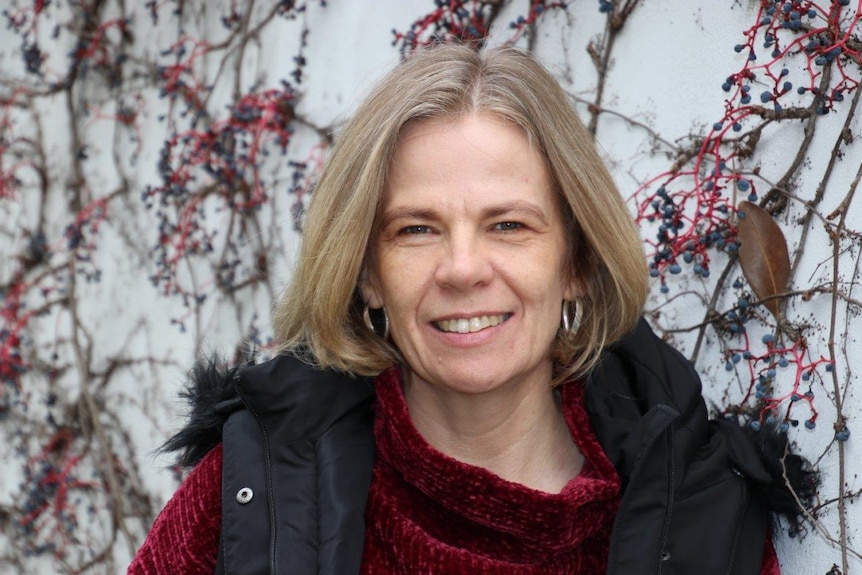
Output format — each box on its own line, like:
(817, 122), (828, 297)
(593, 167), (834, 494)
(129, 46), (813, 574)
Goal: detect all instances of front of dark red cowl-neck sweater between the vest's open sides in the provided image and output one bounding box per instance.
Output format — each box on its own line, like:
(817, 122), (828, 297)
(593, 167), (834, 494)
(362, 369), (620, 575)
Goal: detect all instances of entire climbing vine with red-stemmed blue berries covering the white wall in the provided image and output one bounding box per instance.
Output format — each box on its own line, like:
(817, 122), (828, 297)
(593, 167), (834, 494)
(0, 0), (862, 574)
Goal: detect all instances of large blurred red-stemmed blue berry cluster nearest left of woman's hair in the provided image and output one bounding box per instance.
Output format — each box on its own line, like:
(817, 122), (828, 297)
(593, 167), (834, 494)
(142, 86), (299, 306)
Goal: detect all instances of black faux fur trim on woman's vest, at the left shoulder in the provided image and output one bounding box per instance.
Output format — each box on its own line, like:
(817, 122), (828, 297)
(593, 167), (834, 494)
(160, 358), (242, 468)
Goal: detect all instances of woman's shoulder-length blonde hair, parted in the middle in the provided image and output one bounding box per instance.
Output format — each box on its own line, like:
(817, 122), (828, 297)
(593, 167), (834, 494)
(274, 45), (648, 381)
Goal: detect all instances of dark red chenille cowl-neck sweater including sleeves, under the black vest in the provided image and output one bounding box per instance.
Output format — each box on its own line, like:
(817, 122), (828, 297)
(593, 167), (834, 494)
(128, 372), (780, 575)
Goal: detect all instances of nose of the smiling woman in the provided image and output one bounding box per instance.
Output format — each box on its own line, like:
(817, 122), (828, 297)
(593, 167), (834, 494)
(435, 234), (494, 290)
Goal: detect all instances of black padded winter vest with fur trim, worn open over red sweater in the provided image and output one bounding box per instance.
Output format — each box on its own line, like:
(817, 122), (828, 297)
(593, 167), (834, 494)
(172, 320), (815, 575)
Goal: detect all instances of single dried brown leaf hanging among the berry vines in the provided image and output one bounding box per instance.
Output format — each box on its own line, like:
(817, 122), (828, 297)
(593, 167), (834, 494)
(738, 202), (790, 320)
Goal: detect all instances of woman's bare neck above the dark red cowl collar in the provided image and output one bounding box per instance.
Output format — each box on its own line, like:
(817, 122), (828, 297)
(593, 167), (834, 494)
(404, 375), (583, 493)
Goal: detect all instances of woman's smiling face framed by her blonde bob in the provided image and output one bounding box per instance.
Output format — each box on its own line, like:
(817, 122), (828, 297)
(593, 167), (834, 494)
(361, 114), (574, 394)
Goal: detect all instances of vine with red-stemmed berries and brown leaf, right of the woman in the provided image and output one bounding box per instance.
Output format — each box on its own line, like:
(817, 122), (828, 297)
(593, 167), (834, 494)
(620, 0), (862, 573)
